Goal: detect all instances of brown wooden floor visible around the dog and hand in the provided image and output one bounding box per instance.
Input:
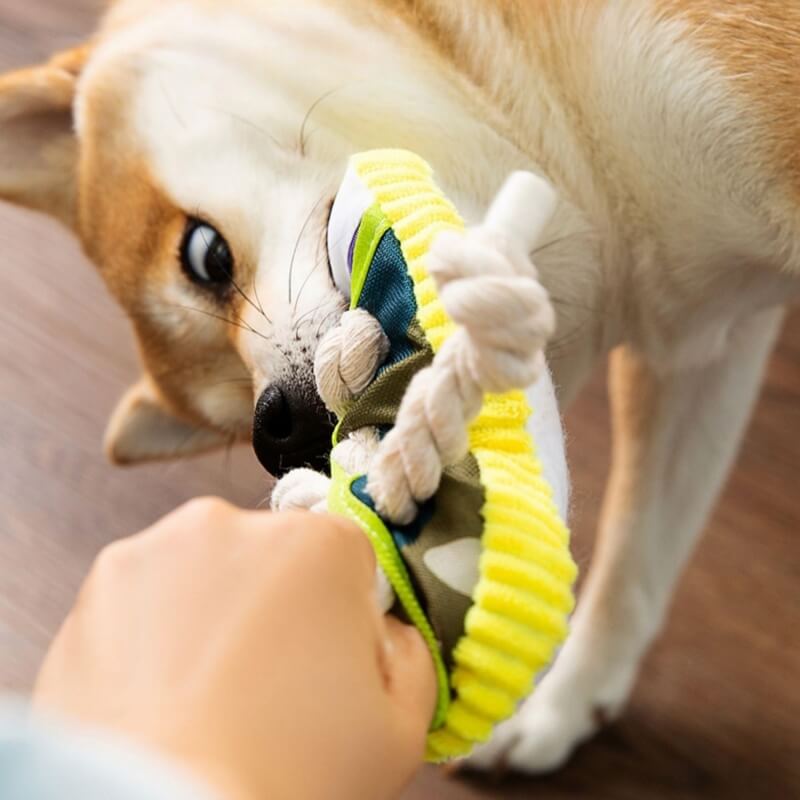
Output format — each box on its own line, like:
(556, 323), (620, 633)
(0, 0), (800, 800)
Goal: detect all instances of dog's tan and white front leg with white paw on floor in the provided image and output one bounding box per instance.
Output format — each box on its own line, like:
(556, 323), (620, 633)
(471, 310), (782, 772)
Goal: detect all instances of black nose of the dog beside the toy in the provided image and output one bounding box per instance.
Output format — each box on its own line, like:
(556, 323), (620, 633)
(253, 383), (333, 478)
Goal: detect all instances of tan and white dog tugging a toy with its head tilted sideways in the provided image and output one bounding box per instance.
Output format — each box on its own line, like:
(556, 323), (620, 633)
(0, 0), (800, 772)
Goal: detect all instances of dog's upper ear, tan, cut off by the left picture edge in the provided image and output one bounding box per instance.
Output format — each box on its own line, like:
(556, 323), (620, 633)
(0, 45), (89, 227)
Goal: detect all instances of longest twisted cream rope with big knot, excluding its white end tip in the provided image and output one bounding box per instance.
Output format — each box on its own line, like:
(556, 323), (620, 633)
(367, 226), (555, 524)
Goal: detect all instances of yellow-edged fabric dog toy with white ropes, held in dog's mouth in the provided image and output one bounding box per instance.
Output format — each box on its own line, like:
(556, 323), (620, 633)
(272, 150), (576, 762)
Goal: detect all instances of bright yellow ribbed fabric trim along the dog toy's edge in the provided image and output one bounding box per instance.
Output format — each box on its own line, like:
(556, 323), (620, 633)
(351, 150), (577, 761)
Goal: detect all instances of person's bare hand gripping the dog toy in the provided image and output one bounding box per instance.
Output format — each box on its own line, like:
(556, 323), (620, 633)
(34, 499), (435, 800)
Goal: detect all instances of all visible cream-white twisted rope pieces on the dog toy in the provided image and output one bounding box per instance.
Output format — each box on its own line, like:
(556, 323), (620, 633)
(271, 173), (555, 596)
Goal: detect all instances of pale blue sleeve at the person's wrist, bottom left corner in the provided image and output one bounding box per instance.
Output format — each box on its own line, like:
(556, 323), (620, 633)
(0, 702), (219, 800)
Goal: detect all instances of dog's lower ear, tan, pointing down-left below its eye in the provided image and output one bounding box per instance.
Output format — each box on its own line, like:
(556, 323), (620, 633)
(105, 377), (228, 465)
